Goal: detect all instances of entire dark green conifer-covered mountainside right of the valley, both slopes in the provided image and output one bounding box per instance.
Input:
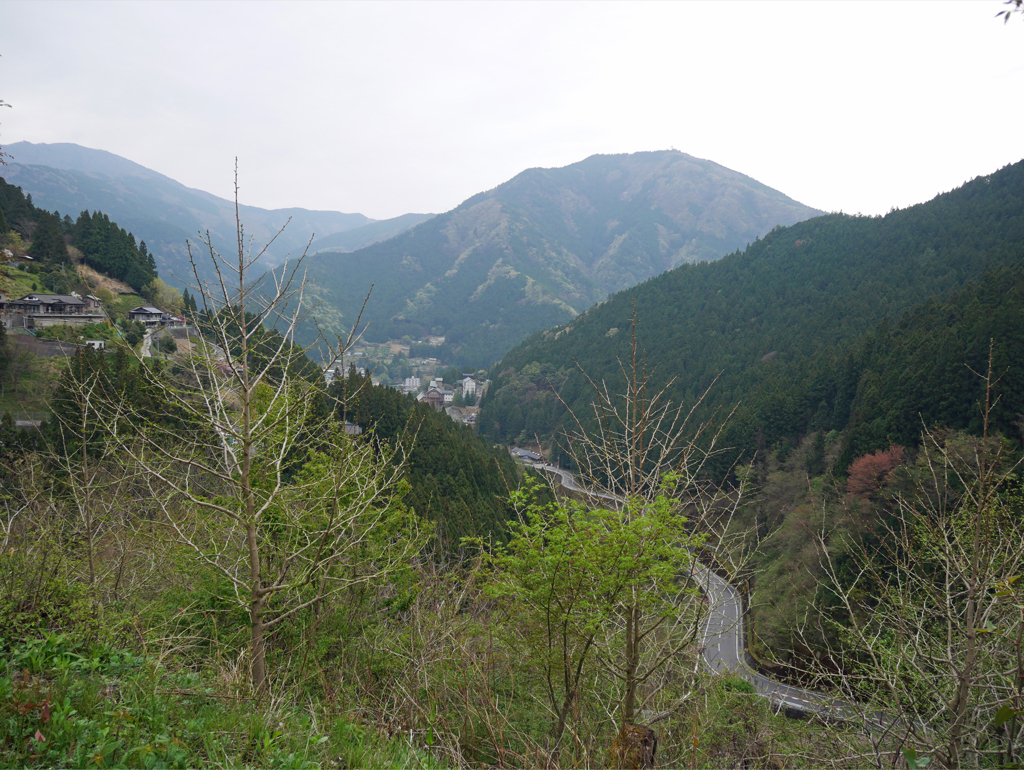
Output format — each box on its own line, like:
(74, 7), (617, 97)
(480, 163), (1024, 462)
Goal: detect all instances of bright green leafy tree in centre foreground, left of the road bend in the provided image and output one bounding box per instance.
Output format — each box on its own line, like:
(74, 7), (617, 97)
(488, 473), (705, 751)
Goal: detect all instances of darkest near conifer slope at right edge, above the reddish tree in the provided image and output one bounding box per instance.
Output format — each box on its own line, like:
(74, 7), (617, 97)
(833, 259), (1024, 462)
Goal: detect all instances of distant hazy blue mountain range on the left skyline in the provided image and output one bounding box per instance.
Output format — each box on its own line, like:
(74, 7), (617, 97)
(4, 141), (374, 283)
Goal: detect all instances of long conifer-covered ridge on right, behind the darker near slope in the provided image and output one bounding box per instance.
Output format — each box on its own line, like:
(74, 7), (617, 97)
(480, 155), (1024, 460)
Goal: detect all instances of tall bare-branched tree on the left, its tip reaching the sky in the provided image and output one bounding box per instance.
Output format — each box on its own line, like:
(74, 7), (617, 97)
(101, 167), (423, 694)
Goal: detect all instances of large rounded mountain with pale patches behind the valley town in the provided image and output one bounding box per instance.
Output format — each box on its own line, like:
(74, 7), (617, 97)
(299, 151), (820, 366)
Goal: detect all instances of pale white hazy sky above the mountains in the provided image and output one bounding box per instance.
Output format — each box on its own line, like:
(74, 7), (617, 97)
(0, 0), (1024, 218)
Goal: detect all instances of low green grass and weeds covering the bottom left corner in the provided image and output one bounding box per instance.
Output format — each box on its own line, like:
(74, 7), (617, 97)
(0, 634), (440, 768)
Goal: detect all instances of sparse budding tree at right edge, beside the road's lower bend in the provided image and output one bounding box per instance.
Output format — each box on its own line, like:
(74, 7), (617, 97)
(821, 344), (1024, 768)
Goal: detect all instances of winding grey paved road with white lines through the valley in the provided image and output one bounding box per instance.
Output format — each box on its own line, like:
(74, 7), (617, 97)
(528, 463), (858, 719)
